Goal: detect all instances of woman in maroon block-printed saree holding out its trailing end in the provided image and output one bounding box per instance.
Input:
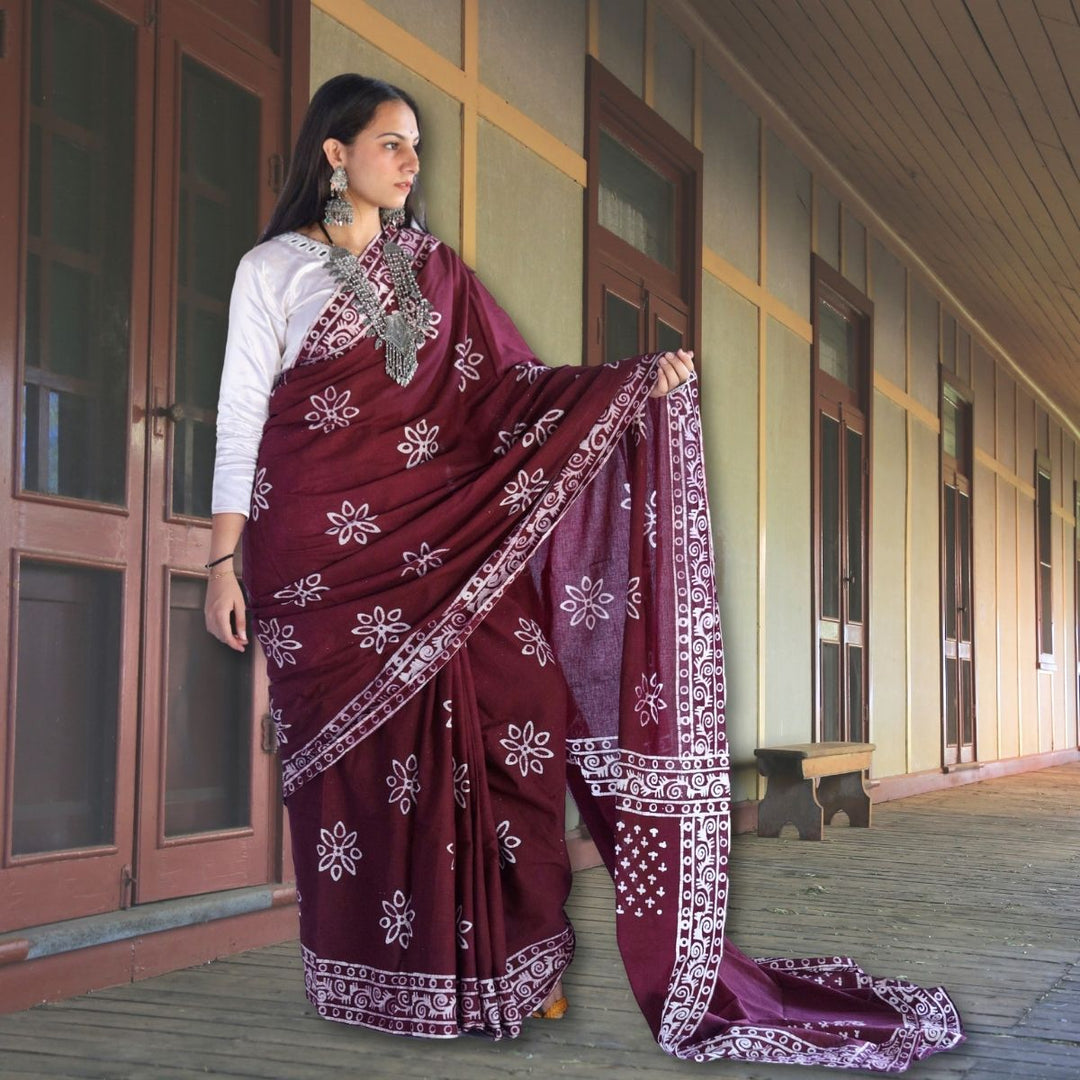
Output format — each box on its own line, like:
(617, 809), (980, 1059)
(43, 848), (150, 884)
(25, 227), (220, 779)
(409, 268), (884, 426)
(206, 76), (962, 1071)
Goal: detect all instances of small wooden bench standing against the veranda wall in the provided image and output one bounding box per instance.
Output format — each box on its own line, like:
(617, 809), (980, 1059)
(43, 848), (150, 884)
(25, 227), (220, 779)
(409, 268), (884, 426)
(754, 742), (875, 840)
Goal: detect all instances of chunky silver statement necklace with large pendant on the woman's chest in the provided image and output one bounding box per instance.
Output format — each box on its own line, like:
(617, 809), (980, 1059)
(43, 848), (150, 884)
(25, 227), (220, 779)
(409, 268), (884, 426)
(323, 220), (431, 387)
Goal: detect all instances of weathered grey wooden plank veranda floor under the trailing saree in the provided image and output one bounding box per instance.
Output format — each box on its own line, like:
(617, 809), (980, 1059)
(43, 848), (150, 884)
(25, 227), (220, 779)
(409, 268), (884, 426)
(0, 764), (1080, 1080)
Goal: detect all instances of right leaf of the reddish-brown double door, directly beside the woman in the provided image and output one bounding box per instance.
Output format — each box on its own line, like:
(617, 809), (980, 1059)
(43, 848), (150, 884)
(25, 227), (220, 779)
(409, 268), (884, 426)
(135, 2), (284, 902)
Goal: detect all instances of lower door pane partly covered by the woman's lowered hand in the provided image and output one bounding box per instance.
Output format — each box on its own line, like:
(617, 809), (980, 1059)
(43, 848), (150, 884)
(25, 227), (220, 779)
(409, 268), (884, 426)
(165, 577), (252, 836)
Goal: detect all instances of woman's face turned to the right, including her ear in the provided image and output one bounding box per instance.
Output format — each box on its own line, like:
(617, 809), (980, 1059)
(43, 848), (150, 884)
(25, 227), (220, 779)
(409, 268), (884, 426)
(323, 100), (420, 213)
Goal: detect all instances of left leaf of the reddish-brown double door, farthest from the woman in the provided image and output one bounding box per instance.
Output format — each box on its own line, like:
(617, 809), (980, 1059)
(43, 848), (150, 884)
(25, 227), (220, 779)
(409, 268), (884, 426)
(0, 0), (153, 931)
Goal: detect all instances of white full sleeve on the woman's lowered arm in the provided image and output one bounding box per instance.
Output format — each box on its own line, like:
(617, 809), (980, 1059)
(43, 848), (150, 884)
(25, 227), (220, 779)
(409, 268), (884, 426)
(212, 248), (286, 516)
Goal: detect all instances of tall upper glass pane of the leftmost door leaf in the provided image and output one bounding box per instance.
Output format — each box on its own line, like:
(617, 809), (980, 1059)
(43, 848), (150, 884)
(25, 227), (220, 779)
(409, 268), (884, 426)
(21, 0), (135, 503)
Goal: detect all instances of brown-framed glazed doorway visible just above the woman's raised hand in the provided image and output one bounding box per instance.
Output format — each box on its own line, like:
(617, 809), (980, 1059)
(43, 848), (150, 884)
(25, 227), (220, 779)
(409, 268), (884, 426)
(584, 58), (701, 364)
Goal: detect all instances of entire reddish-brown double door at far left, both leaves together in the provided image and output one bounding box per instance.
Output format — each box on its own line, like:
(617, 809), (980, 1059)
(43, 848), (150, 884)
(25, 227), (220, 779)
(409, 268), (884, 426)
(0, 0), (295, 932)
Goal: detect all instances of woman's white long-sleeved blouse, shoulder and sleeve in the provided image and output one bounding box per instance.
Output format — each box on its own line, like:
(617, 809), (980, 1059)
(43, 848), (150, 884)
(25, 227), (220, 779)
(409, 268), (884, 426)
(212, 232), (338, 517)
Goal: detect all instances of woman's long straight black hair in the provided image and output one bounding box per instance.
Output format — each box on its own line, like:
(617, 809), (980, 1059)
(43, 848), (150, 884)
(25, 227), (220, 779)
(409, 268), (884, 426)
(259, 73), (427, 243)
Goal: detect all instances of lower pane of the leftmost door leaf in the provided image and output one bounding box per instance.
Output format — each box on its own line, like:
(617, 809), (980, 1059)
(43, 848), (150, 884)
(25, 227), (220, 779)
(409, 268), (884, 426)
(12, 558), (122, 855)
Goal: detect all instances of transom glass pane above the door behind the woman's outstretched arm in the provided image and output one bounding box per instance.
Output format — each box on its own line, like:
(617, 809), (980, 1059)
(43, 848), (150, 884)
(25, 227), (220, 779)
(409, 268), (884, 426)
(598, 130), (676, 270)
